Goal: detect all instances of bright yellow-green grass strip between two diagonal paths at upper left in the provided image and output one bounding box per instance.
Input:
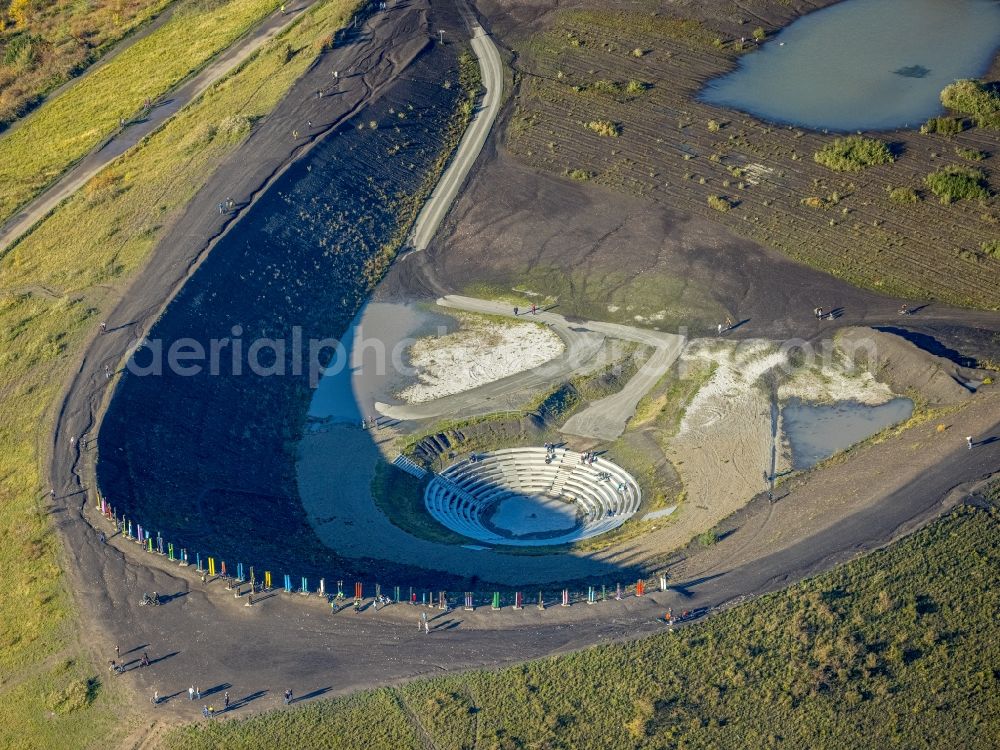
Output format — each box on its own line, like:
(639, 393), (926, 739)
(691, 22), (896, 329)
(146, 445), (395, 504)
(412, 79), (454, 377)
(0, 0), (286, 223)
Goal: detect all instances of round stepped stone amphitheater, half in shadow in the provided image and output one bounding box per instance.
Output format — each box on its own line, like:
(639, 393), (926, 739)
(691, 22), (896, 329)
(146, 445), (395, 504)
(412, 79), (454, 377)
(424, 448), (642, 546)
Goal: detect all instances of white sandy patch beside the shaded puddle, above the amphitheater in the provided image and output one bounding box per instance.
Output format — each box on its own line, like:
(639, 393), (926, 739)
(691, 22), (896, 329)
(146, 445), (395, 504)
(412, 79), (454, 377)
(399, 315), (564, 404)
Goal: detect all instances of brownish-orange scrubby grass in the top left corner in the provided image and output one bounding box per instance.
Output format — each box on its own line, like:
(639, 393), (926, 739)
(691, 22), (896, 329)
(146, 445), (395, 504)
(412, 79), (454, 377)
(0, 0), (172, 129)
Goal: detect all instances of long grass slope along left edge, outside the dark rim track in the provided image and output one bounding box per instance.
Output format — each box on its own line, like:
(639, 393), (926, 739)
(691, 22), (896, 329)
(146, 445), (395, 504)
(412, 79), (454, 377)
(0, 0), (357, 748)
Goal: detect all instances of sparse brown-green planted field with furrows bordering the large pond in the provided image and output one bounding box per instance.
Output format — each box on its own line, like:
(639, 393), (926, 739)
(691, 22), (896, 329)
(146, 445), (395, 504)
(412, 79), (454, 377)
(505, 0), (1000, 308)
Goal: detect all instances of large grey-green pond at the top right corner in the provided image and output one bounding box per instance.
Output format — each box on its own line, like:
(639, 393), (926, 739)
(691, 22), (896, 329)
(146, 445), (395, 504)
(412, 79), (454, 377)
(699, 0), (1000, 131)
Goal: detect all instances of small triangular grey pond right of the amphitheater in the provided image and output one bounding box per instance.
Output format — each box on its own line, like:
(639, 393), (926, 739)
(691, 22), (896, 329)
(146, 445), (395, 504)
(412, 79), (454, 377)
(781, 398), (913, 470)
